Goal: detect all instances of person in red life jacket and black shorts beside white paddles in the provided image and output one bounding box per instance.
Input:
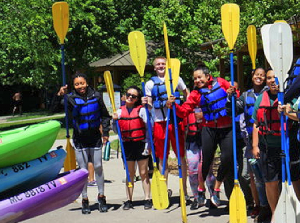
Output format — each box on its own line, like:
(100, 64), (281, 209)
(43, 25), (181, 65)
(252, 70), (281, 222)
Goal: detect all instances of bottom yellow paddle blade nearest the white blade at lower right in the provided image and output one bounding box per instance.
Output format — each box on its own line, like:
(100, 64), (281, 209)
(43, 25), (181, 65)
(229, 183), (247, 223)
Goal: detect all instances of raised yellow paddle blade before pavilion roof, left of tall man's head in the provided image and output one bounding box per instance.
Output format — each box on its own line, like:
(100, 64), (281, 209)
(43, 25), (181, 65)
(128, 31), (147, 77)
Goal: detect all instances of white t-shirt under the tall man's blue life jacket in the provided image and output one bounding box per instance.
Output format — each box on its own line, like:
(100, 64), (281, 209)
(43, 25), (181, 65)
(145, 77), (186, 122)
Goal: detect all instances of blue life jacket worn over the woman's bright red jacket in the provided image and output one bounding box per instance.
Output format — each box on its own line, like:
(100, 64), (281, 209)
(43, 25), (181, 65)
(199, 78), (227, 121)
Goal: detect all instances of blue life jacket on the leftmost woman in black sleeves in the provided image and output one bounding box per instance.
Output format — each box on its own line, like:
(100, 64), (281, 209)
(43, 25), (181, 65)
(69, 92), (101, 132)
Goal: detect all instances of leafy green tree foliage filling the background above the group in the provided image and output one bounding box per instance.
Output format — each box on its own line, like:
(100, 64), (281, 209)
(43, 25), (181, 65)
(0, 0), (300, 89)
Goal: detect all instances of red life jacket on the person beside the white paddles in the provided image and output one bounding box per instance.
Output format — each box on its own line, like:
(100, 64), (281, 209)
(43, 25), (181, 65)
(257, 91), (281, 136)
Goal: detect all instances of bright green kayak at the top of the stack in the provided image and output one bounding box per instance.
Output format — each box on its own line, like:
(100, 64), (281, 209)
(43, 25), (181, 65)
(0, 120), (60, 168)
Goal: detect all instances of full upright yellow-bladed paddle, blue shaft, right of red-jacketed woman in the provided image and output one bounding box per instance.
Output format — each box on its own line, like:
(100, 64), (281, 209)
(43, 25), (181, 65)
(221, 4), (247, 223)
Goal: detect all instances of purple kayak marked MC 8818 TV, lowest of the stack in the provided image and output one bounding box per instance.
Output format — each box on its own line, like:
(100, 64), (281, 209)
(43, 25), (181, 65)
(0, 169), (88, 223)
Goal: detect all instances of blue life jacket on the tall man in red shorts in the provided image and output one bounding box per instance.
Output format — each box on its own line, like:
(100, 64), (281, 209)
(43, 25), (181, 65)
(151, 76), (180, 109)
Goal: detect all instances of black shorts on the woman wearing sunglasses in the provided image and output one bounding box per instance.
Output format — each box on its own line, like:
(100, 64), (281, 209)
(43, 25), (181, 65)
(122, 141), (149, 161)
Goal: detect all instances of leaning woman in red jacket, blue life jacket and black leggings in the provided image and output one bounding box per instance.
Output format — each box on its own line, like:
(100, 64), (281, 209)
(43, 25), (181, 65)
(167, 66), (233, 207)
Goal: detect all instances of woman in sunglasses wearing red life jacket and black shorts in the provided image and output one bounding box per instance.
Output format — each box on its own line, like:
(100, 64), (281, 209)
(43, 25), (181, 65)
(113, 86), (152, 210)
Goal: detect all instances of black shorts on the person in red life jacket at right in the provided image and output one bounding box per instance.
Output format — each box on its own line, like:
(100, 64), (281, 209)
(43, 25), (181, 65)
(258, 147), (281, 182)
